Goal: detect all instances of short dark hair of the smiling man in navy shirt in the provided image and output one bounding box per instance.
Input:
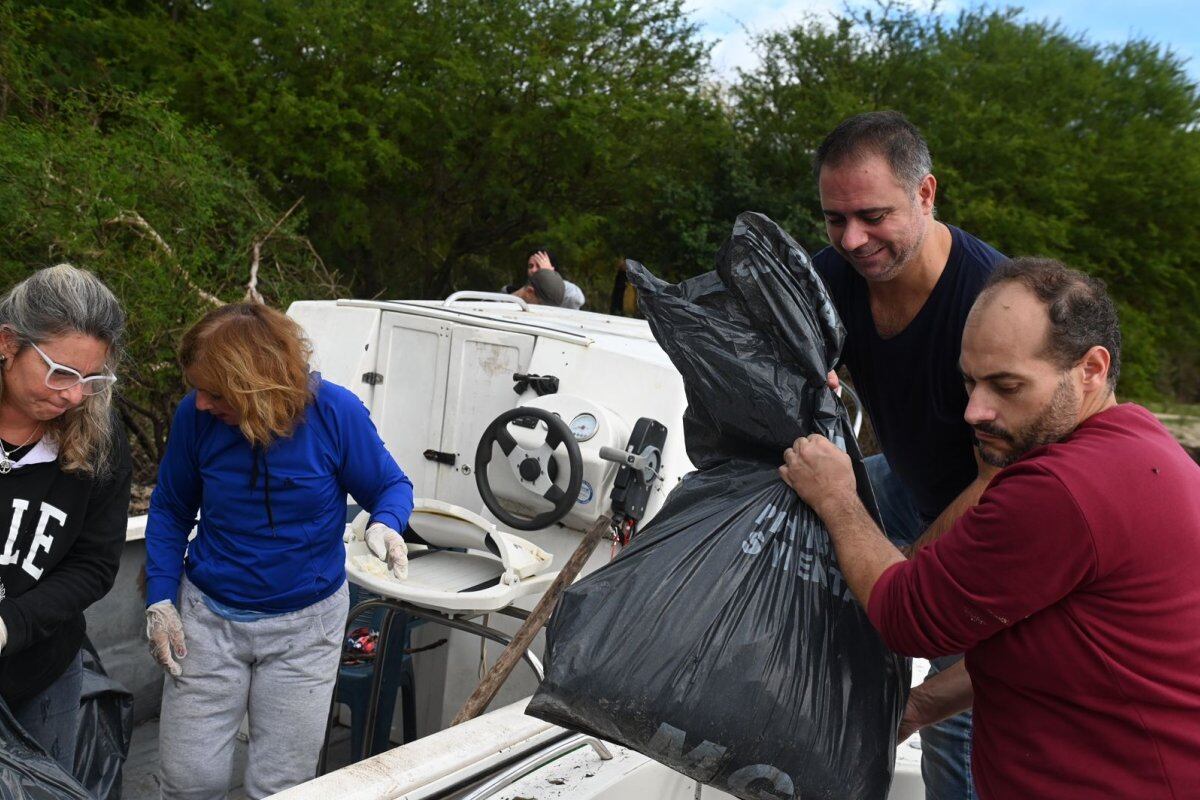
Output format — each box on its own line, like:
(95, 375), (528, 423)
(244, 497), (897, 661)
(812, 112), (934, 192)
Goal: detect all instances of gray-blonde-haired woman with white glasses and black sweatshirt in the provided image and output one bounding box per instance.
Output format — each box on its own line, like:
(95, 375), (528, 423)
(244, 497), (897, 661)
(0, 264), (131, 772)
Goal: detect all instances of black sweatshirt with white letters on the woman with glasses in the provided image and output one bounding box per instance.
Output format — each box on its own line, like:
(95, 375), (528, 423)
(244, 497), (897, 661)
(0, 431), (131, 705)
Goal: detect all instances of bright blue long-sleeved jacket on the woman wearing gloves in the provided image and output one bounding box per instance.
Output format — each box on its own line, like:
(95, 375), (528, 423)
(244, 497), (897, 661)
(146, 373), (413, 613)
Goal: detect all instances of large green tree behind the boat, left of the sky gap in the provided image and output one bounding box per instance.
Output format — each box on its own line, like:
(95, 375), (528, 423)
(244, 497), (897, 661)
(23, 0), (732, 302)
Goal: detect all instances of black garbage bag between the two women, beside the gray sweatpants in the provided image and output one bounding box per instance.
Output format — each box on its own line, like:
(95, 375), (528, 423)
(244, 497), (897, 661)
(74, 639), (133, 800)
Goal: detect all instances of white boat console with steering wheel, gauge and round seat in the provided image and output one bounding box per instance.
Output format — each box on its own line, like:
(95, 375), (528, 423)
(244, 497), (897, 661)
(282, 294), (691, 762)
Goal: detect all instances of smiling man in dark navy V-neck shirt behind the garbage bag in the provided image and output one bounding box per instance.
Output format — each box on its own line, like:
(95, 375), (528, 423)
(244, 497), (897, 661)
(814, 112), (1004, 800)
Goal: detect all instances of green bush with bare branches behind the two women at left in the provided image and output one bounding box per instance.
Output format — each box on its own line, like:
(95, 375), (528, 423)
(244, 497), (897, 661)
(0, 8), (338, 480)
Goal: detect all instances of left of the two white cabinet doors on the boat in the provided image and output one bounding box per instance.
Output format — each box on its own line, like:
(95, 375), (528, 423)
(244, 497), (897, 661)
(371, 312), (454, 498)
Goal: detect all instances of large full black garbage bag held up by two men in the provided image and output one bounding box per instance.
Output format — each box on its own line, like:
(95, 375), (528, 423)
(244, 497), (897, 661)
(528, 213), (908, 800)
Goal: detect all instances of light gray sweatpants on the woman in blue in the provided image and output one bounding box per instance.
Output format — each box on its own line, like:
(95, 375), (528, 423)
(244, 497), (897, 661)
(158, 578), (349, 800)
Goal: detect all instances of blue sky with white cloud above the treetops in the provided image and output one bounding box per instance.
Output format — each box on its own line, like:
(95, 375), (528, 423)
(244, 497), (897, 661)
(685, 0), (1200, 80)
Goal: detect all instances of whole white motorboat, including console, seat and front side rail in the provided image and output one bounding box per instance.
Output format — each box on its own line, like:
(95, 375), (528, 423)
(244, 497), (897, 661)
(88, 293), (924, 800)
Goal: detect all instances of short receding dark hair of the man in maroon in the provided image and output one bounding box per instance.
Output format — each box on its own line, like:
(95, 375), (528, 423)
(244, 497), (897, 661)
(979, 258), (1121, 389)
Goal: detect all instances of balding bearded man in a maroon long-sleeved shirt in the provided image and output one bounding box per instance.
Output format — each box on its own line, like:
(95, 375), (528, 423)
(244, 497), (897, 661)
(780, 259), (1200, 798)
